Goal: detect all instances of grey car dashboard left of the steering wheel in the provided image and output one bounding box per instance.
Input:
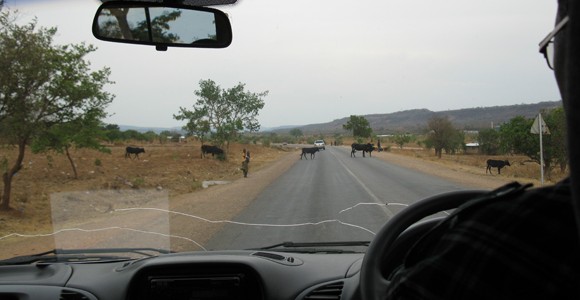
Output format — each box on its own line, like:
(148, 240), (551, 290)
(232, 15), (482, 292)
(0, 250), (364, 300)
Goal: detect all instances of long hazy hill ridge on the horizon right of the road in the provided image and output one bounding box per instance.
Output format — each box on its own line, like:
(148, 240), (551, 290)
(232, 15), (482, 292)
(272, 101), (562, 134)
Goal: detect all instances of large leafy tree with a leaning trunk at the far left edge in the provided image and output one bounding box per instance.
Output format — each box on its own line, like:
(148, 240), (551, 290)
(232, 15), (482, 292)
(0, 11), (114, 210)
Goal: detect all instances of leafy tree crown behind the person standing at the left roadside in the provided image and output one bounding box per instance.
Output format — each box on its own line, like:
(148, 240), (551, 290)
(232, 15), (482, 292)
(173, 79), (268, 148)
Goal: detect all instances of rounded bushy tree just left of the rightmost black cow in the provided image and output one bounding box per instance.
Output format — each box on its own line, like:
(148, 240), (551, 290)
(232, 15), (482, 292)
(425, 115), (463, 158)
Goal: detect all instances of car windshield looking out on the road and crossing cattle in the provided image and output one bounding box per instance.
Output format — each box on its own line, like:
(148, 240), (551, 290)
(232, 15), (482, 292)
(0, 0), (568, 258)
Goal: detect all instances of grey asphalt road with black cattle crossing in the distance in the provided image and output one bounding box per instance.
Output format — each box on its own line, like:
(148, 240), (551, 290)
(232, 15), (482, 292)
(205, 147), (465, 249)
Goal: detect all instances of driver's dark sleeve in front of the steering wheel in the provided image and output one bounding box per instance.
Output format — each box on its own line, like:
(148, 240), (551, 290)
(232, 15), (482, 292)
(386, 180), (580, 299)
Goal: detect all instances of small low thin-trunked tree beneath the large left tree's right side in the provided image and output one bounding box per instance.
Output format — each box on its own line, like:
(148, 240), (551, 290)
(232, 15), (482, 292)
(31, 109), (111, 178)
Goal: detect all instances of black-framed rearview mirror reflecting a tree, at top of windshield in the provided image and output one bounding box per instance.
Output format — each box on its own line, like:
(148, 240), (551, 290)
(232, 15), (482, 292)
(93, 1), (232, 50)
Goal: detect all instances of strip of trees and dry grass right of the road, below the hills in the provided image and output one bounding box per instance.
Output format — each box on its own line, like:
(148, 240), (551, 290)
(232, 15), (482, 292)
(262, 107), (568, 183)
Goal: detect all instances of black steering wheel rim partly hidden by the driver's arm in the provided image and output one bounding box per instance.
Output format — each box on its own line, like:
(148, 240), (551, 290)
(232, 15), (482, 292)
(360, 190), (486, 300)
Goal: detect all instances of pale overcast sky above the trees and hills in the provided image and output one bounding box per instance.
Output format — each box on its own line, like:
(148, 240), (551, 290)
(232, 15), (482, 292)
(5, 0), (560, 128)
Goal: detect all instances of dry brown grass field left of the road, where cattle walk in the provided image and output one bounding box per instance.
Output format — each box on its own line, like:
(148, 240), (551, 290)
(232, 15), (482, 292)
(0, 142), (287, 236)
